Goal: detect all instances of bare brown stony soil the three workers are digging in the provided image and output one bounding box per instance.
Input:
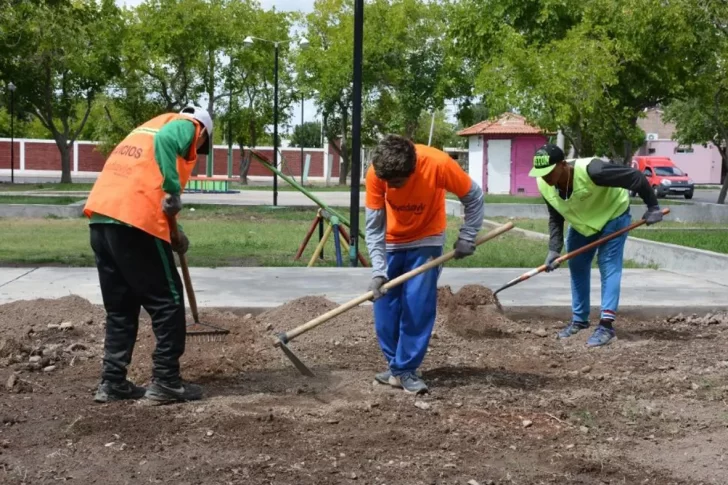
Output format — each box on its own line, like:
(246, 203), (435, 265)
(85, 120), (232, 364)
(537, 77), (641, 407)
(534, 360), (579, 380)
(0, 287), (728, 485)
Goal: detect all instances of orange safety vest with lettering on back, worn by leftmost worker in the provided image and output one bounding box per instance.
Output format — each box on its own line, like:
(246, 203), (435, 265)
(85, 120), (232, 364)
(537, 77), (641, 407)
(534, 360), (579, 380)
(83, 113), (201, 242)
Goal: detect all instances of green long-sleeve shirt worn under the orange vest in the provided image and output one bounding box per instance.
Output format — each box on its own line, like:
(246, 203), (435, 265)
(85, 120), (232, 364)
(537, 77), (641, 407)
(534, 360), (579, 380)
(89, 120), (195, 224)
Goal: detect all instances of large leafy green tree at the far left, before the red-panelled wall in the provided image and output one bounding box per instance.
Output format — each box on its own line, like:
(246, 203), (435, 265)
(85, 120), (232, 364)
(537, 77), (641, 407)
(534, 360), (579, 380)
(0, 0), (123, 183)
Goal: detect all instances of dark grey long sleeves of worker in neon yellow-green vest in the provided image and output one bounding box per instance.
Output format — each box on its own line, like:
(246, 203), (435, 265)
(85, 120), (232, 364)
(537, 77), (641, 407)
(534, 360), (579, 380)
(546, 158), (659, 253)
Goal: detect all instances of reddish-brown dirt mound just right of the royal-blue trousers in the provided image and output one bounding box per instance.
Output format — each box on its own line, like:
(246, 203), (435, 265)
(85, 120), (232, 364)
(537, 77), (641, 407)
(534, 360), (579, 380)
(437, 285), (513, 338)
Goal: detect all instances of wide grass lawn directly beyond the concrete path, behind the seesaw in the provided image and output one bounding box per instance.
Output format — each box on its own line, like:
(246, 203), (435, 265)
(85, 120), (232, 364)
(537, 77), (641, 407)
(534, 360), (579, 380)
(0, 205), (636, 268)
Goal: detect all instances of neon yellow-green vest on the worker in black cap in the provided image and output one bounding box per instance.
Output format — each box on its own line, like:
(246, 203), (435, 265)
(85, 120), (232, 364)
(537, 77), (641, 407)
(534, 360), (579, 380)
(537, 158), (629, 237)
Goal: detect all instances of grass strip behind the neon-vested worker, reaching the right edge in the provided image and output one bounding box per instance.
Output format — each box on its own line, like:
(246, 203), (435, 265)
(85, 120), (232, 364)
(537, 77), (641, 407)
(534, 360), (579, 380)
(492, 213), (728, 254)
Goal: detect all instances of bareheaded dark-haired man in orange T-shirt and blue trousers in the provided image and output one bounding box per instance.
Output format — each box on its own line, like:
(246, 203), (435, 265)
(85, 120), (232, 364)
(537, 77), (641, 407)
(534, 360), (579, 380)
(366, 135), (484, 394)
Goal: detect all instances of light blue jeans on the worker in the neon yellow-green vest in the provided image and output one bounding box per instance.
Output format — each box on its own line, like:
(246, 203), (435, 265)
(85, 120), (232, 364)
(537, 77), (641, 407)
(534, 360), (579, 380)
(566, 210), (632, 323)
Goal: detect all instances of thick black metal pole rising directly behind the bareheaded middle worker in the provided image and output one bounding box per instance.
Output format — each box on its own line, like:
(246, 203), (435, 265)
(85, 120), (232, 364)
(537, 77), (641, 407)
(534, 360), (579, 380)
(349, 0), (364, 268)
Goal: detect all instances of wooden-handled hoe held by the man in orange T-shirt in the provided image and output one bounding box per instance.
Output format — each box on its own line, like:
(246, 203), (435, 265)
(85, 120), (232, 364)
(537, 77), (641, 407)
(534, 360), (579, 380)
(274, 222), (513, 377)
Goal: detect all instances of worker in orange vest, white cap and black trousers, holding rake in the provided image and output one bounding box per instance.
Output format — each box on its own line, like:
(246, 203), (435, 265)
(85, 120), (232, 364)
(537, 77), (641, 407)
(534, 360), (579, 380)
(84, 107), (212, 403)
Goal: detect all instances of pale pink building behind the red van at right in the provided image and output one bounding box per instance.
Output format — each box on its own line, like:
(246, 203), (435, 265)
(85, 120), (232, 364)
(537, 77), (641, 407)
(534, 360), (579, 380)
(635, 108), (723, 184)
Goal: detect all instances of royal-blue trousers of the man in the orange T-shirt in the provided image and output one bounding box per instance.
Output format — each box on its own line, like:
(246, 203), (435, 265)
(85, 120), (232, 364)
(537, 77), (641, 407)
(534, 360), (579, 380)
(374, 246), (442, 376)
